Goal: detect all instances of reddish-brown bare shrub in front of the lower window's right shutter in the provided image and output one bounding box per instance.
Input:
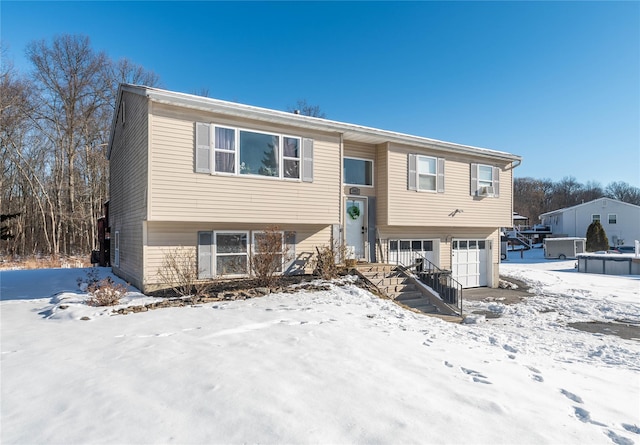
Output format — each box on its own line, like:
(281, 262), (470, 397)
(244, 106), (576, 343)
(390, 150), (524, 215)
(251, 226), (291, 286)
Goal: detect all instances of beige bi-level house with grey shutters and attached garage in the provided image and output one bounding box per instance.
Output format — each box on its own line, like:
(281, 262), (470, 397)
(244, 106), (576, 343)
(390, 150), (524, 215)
(108, 84), (521, 291)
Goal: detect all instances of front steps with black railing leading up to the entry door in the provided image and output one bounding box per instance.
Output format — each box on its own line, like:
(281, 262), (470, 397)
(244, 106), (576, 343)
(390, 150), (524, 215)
(356, 264), (438, 314)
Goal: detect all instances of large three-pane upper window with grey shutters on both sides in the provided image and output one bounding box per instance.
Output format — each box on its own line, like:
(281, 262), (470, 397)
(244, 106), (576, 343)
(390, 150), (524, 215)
(196, 122), (313, 182)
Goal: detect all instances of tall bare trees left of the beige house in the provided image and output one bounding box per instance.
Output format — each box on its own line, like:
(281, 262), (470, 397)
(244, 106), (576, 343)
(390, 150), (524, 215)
(0, 35), (159, 256)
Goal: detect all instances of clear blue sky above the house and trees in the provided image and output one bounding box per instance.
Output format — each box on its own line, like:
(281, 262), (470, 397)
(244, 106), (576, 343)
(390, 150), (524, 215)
(0, 0), (640, 186)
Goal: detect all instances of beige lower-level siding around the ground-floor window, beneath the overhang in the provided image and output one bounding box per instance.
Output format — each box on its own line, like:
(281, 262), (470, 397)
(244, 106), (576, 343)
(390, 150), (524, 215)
(144, 222), (331, 290)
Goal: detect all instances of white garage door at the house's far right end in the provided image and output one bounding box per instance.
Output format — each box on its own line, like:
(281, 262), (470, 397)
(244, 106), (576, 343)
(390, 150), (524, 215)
(451, 239), (489, 288)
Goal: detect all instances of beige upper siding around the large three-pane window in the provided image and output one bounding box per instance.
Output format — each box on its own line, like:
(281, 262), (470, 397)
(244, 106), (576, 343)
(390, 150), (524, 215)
(149, 104), (341, 224)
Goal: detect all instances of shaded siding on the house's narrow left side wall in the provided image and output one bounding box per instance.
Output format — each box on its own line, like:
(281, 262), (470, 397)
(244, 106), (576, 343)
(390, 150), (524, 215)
(109, 92), (148, 287)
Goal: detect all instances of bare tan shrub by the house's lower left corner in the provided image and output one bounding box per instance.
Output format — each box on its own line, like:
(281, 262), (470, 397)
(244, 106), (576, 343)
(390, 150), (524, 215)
(158, 247), (211, 297)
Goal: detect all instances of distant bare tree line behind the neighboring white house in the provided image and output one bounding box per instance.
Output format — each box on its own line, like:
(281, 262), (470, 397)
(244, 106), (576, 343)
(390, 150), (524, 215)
(513, 176), (640, 225)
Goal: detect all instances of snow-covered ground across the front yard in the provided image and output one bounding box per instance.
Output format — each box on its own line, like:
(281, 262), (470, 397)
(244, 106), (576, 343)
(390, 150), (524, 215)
(0, 250), (640, 444)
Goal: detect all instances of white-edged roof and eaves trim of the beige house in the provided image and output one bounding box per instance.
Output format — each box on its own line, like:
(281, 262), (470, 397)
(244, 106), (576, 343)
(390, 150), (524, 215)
(107, 84), (522, 166)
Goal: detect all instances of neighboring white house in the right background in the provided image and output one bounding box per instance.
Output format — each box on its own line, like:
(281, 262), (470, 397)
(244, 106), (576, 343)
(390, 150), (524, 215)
(540, 198), (640, 246)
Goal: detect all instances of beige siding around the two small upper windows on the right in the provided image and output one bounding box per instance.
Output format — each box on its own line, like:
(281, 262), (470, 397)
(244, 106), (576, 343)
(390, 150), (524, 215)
(381, 145), (512, 228)
